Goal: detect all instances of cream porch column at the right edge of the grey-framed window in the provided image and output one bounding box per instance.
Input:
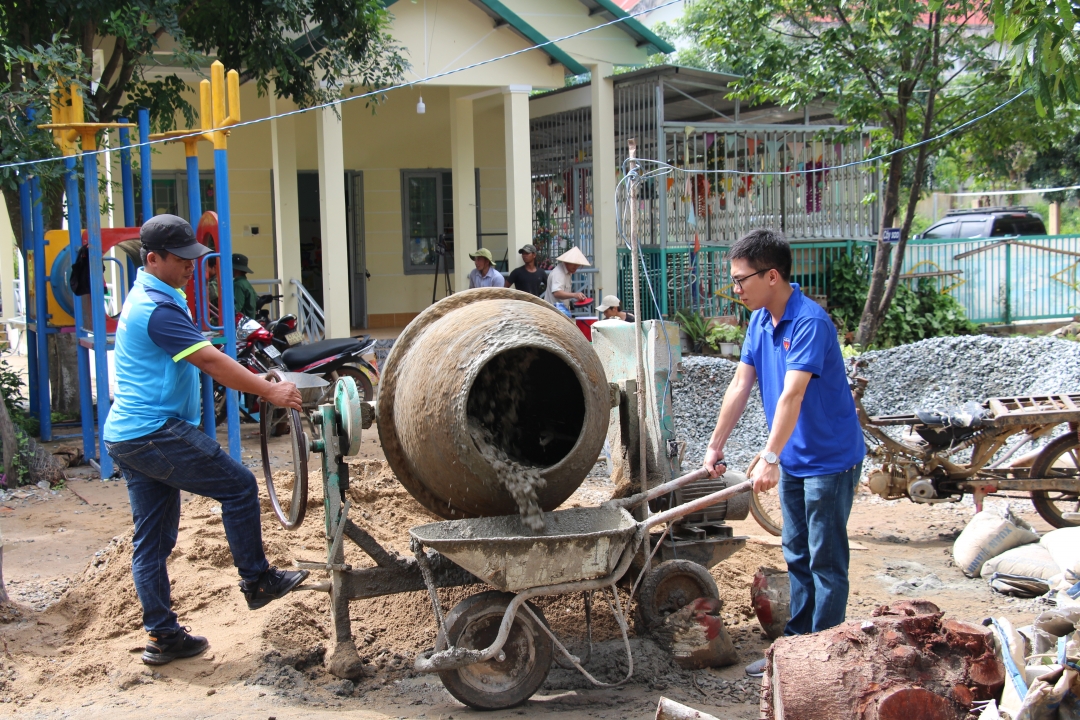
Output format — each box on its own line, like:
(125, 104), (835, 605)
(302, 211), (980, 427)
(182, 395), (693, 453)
(450, 90), (477, 290)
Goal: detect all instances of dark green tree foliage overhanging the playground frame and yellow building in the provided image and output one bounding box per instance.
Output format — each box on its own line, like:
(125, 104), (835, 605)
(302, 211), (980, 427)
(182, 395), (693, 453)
(0, 0), (407, 243)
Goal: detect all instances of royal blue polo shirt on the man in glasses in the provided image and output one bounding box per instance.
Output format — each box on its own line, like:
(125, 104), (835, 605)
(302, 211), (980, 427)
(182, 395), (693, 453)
(742, 283), (866, 477)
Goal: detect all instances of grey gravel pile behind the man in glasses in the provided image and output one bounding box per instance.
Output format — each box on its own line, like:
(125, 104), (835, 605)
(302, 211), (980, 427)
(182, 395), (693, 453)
(673, 335), (1080, 470)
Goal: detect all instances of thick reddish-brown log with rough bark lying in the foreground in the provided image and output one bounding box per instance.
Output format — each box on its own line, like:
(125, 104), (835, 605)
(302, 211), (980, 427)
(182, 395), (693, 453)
(761, 600), (1004, 720)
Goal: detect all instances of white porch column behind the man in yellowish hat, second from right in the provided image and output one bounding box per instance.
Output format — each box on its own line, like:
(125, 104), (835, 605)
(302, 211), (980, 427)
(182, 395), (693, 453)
(502, 85), (532, 257)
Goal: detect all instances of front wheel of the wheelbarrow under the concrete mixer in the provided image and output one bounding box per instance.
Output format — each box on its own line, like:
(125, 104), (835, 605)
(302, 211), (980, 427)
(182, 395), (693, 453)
(435, 590), (554, 710)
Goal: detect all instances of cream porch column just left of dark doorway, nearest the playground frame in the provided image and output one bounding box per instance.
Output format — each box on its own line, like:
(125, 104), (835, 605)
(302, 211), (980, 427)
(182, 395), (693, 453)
(269, 84), (300, 314)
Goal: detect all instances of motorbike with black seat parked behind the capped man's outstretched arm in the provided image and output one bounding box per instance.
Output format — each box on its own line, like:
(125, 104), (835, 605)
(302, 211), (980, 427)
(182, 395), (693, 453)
(214, 313), (379, 424)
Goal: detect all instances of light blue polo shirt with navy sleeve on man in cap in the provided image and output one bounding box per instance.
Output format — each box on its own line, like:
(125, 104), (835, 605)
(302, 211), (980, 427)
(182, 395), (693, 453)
(105, 268), (211, 443)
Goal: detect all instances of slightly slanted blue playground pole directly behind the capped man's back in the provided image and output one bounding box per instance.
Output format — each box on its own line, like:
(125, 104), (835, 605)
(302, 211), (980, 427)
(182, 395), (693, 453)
(82, 151), (112, 480)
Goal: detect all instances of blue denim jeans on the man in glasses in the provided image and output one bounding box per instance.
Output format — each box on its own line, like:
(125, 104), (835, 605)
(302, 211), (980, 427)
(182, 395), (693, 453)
(780, 463), (863, 635)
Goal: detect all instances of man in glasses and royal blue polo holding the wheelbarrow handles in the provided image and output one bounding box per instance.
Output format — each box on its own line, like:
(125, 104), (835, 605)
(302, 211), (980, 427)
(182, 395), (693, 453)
(704, 230), (866, 675)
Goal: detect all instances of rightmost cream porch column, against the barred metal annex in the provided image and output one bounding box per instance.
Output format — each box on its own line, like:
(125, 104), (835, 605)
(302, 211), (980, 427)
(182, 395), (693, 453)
(585, 63), (619, 298)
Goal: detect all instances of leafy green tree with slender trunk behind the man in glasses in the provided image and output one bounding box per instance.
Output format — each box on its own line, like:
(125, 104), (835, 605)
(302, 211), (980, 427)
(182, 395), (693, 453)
(665, 0), (1017, 345)
